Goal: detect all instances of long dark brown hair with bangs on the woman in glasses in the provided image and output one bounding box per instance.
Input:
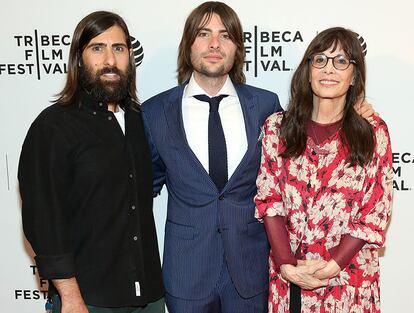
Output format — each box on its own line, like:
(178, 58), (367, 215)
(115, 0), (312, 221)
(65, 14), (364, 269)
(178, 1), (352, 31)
(281, 27), (375, 166)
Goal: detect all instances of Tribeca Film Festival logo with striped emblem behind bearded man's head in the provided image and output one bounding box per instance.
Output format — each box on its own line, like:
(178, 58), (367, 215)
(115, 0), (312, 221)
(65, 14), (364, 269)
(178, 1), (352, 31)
(0, 29), (144, 80)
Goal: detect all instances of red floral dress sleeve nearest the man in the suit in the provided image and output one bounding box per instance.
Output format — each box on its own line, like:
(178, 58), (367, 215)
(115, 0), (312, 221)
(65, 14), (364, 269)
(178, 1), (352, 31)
(254, 113), (286, 221)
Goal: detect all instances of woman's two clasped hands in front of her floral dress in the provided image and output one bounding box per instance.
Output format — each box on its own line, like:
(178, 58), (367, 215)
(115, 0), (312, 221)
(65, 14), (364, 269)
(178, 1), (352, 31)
(280, 259), (341, 290)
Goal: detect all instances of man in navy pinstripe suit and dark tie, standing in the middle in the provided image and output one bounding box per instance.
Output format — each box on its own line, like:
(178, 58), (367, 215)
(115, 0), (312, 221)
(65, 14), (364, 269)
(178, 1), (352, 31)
(143, 2), (281, 313)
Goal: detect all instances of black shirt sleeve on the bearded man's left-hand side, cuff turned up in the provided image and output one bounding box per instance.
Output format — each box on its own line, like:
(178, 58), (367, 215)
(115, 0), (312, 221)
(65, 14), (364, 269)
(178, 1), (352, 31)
(18, 120), (75, 279)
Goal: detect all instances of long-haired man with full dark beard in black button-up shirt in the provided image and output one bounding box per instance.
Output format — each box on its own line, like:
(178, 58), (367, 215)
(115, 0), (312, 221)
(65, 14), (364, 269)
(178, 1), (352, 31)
(18, 11), (164, 313)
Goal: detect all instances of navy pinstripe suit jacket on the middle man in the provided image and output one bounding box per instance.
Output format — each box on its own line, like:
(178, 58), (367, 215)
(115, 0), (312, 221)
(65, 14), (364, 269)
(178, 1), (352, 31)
(143, 84), (281, 300)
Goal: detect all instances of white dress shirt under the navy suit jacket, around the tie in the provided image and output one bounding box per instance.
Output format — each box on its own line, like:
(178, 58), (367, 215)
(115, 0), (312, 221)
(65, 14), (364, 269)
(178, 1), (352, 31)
(182, 75), (247, 179)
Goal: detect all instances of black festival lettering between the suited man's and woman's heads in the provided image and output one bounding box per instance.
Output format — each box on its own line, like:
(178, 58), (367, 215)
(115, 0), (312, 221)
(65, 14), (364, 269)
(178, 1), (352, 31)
(243, 25), (303, 77)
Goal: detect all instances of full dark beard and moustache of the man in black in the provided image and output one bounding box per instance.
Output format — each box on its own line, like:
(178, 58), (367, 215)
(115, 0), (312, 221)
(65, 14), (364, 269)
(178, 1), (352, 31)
(79, 65), (133, 103)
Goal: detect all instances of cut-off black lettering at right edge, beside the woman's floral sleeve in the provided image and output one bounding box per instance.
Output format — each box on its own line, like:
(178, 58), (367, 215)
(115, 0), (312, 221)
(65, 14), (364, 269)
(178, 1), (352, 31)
(392, 151), (414, 191)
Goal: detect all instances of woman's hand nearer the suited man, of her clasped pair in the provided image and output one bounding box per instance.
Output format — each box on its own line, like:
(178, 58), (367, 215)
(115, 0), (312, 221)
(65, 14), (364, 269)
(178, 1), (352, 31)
(280, 260), (328, 290)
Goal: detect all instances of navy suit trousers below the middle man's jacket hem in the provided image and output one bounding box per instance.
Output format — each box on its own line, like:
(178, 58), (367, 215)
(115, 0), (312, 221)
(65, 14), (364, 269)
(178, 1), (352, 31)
(165, 261), (268, 313)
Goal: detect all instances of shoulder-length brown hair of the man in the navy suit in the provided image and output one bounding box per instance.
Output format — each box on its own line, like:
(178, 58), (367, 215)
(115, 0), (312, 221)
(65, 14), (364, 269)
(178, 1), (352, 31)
(177, 1), (246, 84)
